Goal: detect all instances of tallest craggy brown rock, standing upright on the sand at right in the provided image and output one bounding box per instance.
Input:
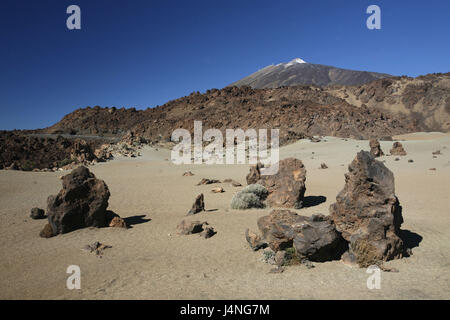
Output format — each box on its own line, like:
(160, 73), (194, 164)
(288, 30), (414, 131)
(330, 151), (403, 265)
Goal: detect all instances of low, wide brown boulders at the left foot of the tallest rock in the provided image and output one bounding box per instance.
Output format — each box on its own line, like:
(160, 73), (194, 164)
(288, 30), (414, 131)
(258, 210), (346, 262)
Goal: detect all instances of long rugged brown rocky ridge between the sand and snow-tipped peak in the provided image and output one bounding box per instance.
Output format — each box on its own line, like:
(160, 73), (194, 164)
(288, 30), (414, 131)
(41, 74), (450, 146)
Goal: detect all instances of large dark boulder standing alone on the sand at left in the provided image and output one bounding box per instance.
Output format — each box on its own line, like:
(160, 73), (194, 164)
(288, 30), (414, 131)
(47, 166), (110, 235)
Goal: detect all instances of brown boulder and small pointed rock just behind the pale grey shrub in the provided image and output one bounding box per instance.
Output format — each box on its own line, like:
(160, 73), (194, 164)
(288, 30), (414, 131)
(247, 158), (306, 208)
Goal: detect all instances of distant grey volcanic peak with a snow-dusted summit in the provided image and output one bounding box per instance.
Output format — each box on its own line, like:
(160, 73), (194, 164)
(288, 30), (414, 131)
(231, 58), (390, 88)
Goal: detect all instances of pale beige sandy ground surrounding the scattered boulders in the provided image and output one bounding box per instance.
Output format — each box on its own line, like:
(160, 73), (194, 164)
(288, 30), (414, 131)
(0, 133), (450, 299)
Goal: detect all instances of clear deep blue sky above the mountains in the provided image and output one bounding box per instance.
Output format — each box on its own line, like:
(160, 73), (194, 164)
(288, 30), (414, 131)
(0, 0), (450, 129)
